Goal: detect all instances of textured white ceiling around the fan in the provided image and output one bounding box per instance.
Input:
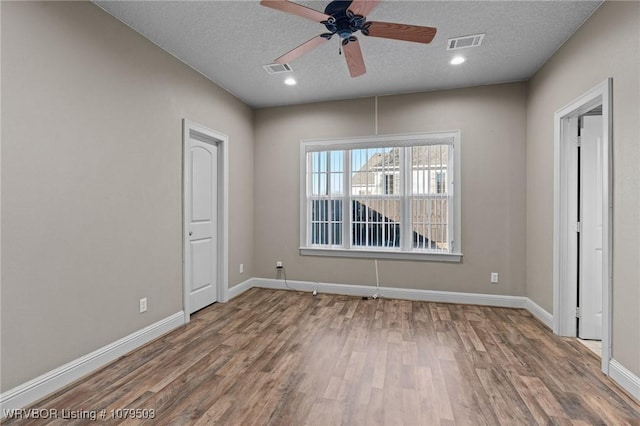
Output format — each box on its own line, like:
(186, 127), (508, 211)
(95, 0), (601, 108)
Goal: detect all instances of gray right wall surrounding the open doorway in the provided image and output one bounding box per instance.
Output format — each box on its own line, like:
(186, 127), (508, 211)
(526, 2), (640, 375)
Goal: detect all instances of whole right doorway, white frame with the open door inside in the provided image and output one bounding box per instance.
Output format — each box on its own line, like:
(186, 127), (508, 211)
(553, 79), (612, 374)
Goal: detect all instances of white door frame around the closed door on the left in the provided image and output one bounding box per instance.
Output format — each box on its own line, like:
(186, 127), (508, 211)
(182, 118), (229, 323)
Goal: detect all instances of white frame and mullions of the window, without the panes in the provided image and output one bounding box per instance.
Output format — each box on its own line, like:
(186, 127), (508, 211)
(299, 130), (462, 262)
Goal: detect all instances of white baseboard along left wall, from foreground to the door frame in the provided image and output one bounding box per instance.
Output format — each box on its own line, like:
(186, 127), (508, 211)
(0, 311), (185, 417)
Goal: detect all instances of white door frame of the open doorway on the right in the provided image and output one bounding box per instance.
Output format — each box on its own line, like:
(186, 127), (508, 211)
(553, 78), (613, 375)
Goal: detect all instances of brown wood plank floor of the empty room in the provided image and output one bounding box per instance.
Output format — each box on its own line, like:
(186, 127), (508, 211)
(6, 288), (640, 425)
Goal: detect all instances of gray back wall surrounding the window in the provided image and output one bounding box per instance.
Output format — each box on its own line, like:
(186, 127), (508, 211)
(254, 83), (526, 296)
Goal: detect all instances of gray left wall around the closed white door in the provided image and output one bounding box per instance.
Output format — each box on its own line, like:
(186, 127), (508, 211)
(1, 2), (254, 391)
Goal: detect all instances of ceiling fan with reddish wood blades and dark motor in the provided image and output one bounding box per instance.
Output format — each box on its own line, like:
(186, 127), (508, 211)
(260, 0), (436, 77)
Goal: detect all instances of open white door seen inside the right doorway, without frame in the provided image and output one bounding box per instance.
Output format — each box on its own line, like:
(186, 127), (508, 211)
(578, 116), (604, 340)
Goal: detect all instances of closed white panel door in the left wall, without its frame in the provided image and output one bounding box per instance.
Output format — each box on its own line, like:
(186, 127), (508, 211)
(185, 134), (218, 313)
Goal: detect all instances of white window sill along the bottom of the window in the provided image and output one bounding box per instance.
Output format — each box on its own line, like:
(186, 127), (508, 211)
(300, 247), (462, 263)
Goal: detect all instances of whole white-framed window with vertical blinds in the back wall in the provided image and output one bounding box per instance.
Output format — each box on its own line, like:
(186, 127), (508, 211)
(300, 132), (462, 261)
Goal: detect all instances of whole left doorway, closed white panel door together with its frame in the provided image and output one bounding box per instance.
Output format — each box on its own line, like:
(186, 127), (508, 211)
(183, 120), (228, 322)
